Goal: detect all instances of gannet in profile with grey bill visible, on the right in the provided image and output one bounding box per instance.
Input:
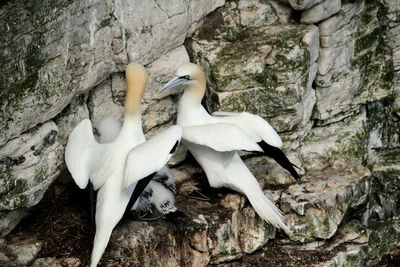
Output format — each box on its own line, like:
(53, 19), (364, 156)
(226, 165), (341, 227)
(160, 63), (299, 233)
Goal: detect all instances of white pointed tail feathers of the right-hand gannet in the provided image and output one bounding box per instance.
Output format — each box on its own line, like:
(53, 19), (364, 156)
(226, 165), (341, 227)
(246, 189), (291, 235)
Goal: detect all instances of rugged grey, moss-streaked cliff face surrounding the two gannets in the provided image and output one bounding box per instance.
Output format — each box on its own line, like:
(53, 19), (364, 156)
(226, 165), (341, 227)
(0, 0), (400, 266)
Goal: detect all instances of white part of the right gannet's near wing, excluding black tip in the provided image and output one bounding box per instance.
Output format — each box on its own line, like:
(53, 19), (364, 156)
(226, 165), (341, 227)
(182, 122), (262, 152)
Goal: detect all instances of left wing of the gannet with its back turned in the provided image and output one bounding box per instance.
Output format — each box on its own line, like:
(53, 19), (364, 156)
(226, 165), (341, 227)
(65, 119), (106, 189)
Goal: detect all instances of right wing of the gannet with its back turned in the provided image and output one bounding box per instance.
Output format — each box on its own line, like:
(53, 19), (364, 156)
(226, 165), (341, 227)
(123, 125), (182, 191)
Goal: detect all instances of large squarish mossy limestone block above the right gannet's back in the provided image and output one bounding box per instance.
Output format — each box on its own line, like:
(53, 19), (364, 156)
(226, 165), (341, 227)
(193, 25), (319, 134)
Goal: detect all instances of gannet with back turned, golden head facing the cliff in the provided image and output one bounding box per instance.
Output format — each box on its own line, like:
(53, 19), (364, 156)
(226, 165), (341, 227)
(65, 64), (182, 267)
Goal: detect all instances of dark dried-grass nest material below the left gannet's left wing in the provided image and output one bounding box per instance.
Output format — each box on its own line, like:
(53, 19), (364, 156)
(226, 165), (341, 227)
(12, 185), (93, 265)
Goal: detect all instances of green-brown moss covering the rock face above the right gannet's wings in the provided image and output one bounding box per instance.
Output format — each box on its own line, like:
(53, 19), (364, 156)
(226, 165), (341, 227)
(206, 25), (310, 130)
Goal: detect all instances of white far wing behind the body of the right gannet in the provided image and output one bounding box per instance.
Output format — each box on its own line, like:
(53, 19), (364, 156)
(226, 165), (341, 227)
(213, 112), (282, 148)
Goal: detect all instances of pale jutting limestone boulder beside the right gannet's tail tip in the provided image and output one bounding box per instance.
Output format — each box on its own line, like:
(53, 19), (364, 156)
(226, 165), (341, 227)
(280, 161), (370, 242)
